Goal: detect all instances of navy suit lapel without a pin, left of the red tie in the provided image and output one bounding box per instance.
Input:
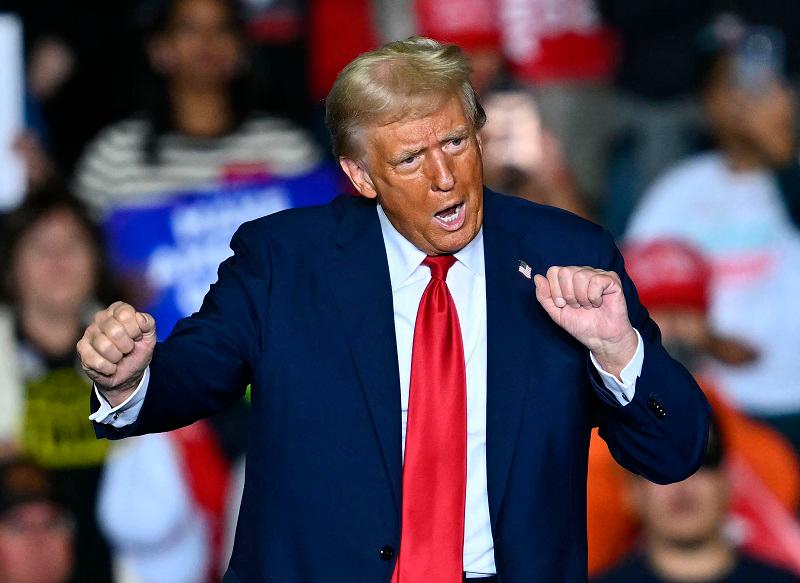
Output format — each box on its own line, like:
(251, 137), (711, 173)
(326, 199), (402, 516)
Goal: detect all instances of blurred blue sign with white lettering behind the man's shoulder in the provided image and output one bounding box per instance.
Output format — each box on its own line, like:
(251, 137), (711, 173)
(104, 166), (342, 339)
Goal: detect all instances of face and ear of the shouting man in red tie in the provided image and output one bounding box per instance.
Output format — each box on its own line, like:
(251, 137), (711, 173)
(341, 96), (483, 255)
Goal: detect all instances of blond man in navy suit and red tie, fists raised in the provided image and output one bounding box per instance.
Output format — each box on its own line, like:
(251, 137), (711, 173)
(78, 39), (708, 583)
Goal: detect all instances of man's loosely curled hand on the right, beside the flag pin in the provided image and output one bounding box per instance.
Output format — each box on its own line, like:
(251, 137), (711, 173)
(533, 266), (639, 378)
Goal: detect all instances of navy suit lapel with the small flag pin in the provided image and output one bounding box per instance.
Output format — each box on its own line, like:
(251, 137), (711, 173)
(484, 190), (542, 532)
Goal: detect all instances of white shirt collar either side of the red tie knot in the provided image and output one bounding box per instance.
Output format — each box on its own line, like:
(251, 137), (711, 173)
(377, 205), (486, 291)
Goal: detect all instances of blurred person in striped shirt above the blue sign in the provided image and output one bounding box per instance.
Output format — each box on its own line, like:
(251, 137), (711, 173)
(76, 0), (319, 214)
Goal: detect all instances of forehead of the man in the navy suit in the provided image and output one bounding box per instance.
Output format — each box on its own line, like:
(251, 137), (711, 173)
(366, 95), (471, 150)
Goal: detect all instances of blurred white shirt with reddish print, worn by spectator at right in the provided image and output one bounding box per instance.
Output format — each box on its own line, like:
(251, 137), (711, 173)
(627, 153), (800, 415)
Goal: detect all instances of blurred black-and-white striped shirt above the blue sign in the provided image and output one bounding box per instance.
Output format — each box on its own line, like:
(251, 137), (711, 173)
(75, 117), (320, 214)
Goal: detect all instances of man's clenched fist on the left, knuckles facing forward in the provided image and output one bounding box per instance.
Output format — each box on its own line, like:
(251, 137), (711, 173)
(77, 302), (156, 407)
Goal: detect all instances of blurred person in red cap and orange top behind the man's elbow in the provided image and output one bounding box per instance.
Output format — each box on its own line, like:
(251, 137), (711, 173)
(587, 239), (800, 574)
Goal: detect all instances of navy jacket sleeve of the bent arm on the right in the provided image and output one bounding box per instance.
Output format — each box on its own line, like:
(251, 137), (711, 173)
(587, 233), (710, 484)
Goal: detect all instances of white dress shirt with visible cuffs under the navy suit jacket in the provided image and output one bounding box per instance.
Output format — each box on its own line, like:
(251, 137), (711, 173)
(89, 206), (644, 577)
